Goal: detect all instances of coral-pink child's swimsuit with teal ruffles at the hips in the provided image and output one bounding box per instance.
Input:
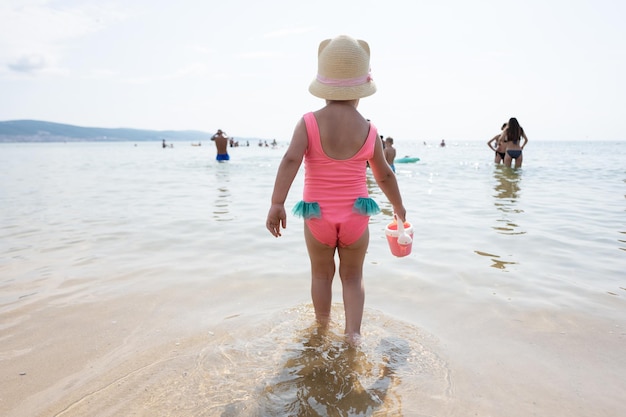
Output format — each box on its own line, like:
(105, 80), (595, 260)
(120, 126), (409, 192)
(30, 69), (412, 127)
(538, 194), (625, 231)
(294, 113), (380, 247)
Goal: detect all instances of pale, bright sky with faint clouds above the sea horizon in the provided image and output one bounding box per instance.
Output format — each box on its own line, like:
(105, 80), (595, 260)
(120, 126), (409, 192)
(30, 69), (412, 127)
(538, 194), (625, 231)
(0, 0), (626, 143)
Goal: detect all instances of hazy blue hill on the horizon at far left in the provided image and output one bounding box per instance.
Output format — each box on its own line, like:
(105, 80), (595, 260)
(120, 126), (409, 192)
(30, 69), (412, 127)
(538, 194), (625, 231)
(0, 120), (212, 142)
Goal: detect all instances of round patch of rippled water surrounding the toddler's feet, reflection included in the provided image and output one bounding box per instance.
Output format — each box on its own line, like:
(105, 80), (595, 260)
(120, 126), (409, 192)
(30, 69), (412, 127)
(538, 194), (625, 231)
(210, 304), (451, 417)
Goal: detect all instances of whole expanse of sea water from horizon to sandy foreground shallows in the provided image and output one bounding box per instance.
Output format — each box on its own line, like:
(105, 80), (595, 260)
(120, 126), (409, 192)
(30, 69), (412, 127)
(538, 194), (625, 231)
(0, 138), (626, 417)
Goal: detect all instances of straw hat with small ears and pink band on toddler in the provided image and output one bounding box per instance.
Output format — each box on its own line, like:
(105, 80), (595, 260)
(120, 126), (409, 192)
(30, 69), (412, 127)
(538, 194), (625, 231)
(309, 35), (376, 100)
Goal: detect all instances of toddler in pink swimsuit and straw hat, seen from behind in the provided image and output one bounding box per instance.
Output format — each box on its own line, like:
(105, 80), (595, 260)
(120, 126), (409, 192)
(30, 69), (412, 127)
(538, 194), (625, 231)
(266, 35), (406, 344)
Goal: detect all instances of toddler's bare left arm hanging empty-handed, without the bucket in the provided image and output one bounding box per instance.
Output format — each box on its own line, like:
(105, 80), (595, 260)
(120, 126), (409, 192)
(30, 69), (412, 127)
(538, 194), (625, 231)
(265, 119), (309, 237)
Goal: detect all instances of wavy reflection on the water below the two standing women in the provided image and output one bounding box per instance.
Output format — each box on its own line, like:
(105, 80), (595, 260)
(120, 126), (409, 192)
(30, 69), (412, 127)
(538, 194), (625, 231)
(493, 165), (526, 235)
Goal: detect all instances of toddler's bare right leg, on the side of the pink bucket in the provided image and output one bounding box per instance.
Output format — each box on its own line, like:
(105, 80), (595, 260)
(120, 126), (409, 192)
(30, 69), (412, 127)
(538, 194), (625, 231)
(338, 229), (369, 342)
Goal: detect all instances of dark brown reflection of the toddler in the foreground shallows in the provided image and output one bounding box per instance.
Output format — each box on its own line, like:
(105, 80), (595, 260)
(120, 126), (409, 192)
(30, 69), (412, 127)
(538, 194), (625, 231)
(259, 326), (409, 416)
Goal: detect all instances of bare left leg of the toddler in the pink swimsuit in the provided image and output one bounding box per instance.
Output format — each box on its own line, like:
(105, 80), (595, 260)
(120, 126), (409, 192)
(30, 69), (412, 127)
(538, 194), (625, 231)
(304, 223), (335, 326)
